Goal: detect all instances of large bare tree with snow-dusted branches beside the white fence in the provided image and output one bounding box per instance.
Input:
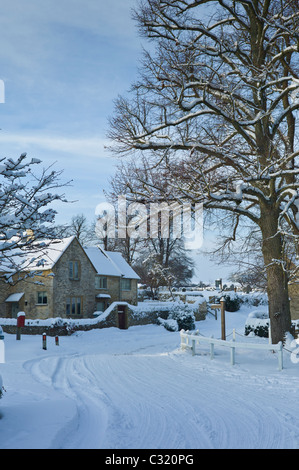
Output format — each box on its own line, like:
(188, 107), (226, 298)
(110, 0), (299, 343)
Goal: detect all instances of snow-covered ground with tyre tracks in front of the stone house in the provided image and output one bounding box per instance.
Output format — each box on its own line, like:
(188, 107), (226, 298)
(0, 307), (299, 449)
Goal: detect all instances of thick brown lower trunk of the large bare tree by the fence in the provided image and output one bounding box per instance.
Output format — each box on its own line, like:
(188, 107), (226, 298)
(260, 208), (291, 344)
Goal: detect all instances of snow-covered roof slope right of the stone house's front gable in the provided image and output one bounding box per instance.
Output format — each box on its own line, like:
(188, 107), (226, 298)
(84, 246), (139, 279)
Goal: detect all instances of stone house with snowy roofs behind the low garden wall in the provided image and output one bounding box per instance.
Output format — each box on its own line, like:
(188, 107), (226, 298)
(0, 236), (138, 319)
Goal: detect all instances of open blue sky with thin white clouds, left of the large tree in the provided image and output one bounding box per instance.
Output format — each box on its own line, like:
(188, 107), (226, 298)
(0, 0), (231, 280)
